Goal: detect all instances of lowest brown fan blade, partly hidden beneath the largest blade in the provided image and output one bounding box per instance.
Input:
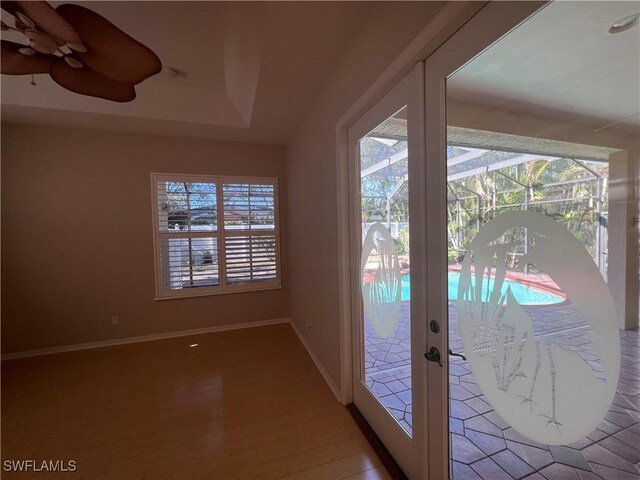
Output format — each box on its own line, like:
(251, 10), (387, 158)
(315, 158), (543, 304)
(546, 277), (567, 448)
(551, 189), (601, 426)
(49, 59), (136, 102)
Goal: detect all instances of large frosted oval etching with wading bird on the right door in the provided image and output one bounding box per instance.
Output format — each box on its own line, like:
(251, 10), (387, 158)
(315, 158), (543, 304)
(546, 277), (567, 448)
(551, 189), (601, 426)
(457, 211), (620, 445)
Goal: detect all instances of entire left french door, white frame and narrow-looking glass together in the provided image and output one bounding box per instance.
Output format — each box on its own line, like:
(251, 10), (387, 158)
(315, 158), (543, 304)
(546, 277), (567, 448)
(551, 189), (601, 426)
(348, 65), (436, 478)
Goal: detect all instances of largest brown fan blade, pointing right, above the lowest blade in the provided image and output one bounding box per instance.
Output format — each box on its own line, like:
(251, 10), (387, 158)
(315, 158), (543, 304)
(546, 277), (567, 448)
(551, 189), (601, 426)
(56, 4), (162, 84)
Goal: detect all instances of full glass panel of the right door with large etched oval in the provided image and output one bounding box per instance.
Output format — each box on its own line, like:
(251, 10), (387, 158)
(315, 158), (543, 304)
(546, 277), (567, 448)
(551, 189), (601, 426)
(446, 2), (640, 480)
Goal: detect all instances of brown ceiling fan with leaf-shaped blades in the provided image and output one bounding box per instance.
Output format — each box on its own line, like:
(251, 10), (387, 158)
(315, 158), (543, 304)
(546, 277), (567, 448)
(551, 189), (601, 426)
(0, 1), (162, 102)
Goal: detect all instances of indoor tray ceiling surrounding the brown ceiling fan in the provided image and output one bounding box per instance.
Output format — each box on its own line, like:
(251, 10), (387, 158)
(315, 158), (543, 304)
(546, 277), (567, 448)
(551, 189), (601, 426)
(2, 1), (376, 144)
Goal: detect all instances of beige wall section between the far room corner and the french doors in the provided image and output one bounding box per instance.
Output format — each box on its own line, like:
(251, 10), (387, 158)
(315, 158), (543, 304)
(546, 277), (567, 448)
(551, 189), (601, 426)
(287, 2), (442, 385)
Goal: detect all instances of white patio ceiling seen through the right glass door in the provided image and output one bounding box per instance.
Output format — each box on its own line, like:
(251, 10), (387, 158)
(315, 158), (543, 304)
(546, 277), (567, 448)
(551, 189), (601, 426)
(447, 1), (640, 132)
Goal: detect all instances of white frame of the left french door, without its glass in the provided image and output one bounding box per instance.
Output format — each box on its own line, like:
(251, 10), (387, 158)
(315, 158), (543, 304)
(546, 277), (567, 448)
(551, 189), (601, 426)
(348, 68), (427, 478)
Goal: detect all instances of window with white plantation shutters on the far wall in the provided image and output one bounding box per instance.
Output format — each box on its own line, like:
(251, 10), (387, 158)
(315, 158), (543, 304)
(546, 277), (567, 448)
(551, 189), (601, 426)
(151, 174), (280, 298)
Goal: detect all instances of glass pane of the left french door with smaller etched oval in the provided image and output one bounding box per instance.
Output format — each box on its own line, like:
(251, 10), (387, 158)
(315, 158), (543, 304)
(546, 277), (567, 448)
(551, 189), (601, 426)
(358, 107), (412, 435)
